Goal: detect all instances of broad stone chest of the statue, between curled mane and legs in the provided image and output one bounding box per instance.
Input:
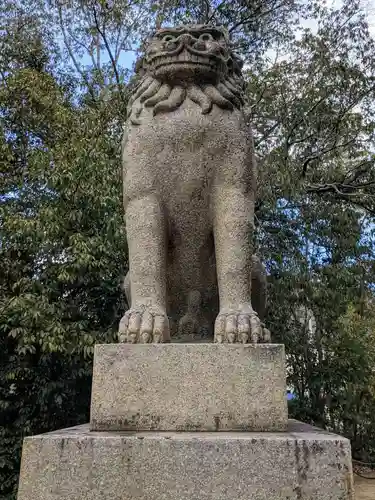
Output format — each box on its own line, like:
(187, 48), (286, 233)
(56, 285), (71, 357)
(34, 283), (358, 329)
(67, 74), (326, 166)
(123, 100), (253, 204)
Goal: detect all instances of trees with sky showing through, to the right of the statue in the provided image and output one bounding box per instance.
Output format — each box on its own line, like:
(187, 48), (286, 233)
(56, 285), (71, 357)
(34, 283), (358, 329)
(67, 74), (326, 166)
(248, 0), (375, 458)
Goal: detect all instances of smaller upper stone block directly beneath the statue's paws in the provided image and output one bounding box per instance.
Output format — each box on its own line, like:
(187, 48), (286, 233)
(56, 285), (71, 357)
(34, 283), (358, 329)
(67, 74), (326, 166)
(91, 344), (287, 431)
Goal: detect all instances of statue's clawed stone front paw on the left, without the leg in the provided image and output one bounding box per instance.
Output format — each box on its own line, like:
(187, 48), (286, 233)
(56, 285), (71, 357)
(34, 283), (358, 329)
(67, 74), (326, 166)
(118, 306), (170, 344)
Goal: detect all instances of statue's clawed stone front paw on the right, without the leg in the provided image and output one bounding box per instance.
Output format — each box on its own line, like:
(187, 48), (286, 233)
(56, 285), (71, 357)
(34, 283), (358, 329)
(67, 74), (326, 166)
(215, 306), (271, 344)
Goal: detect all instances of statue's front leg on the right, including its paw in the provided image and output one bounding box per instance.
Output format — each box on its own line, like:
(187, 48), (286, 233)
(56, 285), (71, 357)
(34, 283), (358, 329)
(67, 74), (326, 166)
(212, 186), (264, 343)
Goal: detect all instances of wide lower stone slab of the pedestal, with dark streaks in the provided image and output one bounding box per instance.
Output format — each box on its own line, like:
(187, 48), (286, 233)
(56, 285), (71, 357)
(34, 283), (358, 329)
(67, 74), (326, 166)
(18, 422), (354, 500)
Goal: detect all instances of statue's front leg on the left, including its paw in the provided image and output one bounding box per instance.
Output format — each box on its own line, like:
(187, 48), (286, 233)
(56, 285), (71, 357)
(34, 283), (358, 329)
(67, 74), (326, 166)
(119, 195), (170, 343)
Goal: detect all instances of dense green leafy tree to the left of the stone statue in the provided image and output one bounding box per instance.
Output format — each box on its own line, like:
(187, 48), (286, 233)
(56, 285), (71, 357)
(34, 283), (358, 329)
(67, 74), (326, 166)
(0, 3), (127, 498)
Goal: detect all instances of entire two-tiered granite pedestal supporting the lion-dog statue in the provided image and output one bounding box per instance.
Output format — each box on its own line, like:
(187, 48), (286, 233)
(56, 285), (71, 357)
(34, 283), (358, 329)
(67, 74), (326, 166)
(18, 344), (354, 500)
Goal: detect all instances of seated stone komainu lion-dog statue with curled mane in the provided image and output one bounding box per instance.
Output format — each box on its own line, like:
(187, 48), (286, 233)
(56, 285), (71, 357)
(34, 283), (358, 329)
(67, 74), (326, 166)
(119, 25), (269, 343)
